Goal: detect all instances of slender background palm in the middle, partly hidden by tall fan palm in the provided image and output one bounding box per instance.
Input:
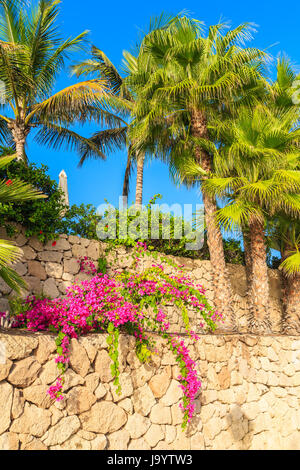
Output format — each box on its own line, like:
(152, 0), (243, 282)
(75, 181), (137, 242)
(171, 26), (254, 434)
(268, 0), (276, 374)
(73, 14), (170, 206)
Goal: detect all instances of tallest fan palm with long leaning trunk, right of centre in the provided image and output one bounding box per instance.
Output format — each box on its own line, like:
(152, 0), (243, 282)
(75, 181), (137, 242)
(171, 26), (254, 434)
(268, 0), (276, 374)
(133, 17), (265, 323)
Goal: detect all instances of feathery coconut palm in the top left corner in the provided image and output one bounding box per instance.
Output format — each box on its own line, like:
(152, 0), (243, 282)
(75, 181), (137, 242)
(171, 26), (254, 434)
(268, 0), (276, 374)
(0, 0), (110, 161)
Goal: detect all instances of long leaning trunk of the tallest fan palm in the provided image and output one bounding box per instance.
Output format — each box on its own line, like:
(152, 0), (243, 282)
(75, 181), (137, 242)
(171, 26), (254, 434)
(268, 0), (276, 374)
(191, 112), (236, 330)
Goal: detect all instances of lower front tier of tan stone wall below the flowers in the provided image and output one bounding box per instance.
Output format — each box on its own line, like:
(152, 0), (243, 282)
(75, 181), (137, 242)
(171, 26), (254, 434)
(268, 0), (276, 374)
(0, 330), (300, 450)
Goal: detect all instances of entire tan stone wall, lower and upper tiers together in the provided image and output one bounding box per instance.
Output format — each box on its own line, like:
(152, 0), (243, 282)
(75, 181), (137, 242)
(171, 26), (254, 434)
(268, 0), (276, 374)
(0, 228), (300, 450)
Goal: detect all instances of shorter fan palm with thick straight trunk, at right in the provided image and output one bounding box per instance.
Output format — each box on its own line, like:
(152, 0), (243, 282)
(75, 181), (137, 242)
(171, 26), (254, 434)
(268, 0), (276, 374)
(203, 105), (300, 332)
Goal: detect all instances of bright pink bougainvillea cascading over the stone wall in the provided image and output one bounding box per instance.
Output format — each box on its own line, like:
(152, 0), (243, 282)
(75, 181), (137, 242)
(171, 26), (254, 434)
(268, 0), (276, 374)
(11, 243), (221, 428)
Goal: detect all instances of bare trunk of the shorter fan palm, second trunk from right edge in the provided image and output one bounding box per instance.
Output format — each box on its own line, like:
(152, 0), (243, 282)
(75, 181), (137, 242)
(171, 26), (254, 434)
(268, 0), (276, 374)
(249, 217), (270, 333)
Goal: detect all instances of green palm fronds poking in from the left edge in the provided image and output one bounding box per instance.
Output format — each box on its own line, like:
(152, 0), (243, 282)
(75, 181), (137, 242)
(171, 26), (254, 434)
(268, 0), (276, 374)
(0, 155), (46, 292)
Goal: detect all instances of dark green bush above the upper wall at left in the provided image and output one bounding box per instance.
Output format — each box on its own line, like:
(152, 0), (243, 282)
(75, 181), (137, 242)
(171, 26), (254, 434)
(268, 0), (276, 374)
(0, 158), (106, 242)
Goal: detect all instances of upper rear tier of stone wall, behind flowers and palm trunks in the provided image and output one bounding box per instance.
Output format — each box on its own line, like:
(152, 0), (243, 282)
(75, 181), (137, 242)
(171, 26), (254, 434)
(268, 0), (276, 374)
(0, 227), (282, 333)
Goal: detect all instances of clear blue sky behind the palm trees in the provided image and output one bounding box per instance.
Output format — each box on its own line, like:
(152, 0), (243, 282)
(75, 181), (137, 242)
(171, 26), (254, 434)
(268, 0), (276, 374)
(27, 0), (300, 213)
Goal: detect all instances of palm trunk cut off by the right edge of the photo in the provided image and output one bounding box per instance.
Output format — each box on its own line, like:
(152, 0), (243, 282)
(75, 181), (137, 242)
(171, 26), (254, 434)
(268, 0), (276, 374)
(284, 273), (300, 334)
